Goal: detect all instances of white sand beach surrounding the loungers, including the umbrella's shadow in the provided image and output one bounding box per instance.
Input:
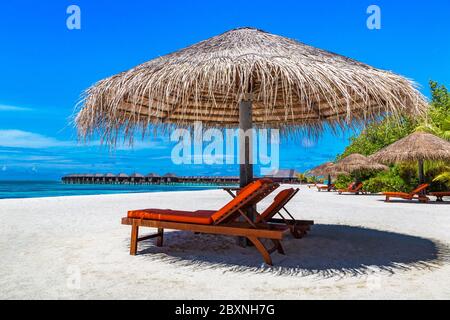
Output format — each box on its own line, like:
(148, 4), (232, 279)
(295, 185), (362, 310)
(0, 186), (450, 299)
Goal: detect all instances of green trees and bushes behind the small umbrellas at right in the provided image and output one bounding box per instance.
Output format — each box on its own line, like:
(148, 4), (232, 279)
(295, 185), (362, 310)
(336, 81), (450, 193)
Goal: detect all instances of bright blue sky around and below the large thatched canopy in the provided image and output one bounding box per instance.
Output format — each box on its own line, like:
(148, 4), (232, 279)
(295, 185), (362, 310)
(0, 0), (450, 180)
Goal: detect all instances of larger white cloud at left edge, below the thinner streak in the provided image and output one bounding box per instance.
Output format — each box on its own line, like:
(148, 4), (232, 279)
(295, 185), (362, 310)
(0, 130), (74, 149)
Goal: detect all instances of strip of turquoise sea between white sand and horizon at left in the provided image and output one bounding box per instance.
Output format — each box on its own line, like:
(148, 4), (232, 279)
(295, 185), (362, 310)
(0, 181), (229, 199)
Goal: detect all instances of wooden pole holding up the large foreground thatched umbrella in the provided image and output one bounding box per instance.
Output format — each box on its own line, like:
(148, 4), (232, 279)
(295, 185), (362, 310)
(238, 94), (256, 247)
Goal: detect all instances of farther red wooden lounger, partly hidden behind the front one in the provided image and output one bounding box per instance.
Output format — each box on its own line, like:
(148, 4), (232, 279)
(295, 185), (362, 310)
(256, 188), (314, 239)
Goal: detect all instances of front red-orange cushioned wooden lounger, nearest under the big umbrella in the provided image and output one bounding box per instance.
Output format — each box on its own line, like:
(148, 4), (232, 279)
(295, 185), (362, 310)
(122, 179), (302, 265)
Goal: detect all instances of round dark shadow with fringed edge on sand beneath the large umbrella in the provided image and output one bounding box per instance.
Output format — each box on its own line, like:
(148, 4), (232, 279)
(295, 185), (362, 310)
(134, 225), (450, 277)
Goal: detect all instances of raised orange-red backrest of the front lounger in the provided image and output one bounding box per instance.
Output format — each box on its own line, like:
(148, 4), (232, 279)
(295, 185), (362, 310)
(211, 179), (273, 222)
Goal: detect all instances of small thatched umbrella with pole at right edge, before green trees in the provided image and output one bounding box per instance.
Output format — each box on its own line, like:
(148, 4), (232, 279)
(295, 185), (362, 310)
(370, 132), (450, 184)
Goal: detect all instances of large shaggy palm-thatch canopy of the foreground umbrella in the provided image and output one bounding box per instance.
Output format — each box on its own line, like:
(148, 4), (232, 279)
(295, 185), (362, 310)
(75, 28), (426, 143)
